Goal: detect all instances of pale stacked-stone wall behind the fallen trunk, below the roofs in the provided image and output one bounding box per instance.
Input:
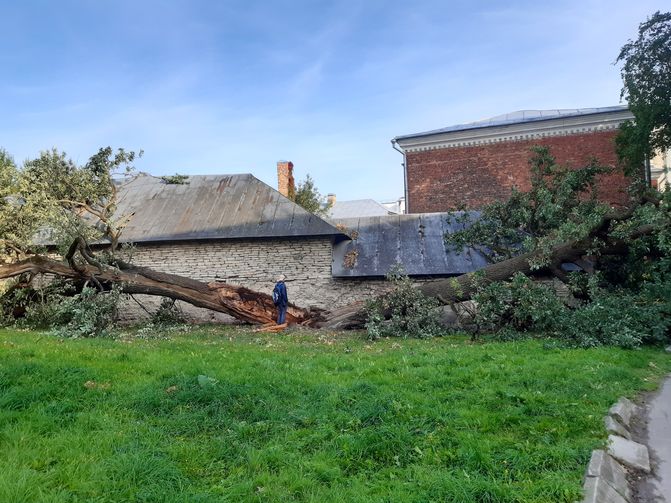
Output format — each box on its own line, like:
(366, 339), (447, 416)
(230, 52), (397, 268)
(122, 237), (388, 322)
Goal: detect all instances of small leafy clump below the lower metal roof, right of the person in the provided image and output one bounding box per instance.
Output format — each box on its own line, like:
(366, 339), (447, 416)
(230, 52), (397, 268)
(366, 267), (442, 340)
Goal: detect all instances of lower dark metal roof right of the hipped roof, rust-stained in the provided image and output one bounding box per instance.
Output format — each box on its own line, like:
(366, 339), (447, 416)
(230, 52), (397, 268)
(332, 213), (487, 277)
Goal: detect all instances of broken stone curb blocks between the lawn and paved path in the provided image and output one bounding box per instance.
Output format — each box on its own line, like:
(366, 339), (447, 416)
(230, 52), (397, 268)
(583, 398), (650, 503)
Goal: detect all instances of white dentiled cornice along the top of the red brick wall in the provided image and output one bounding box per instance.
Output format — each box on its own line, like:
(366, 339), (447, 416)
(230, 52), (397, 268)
(396, 110), (634, 152)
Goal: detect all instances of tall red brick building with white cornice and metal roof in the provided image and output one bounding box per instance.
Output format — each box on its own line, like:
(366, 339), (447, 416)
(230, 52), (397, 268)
(392, 106), (632, 213)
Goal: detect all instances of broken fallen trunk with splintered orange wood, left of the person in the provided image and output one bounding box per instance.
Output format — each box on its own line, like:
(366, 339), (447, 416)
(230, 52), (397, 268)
(0, 255), (321, 325)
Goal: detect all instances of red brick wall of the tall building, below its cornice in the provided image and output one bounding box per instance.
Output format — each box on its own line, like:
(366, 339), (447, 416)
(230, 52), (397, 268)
(406, 131), (627, 213)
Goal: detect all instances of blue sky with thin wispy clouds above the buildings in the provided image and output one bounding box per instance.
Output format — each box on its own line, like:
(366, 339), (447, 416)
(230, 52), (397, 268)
(0, 0), (669, 201)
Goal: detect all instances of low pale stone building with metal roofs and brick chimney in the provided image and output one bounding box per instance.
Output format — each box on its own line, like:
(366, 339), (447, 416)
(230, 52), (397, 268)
(117, 167), (484, 321)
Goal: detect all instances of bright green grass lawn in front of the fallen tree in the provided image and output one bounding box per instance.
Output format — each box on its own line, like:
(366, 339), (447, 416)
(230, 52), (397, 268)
(0, 328), (671, 503)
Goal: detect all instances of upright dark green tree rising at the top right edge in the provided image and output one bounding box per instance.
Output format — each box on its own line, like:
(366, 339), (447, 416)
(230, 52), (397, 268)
(616, 11), (671, 178)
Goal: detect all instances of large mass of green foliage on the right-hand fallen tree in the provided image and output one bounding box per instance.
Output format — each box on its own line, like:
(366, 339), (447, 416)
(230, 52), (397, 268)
(445, 134), (671, 348)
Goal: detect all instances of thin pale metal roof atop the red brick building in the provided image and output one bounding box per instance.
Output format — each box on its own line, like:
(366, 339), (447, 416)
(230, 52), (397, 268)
(394, 105), (628, 140)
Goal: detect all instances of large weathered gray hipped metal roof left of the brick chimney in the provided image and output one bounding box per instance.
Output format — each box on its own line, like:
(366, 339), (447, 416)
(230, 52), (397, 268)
(116, 174), (341, 242)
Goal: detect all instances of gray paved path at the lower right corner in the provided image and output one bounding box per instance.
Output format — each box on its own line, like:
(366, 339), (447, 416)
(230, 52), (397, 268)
(641, 376), (671, 503)
